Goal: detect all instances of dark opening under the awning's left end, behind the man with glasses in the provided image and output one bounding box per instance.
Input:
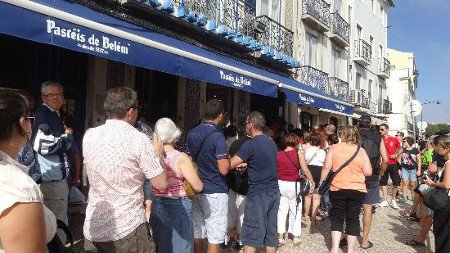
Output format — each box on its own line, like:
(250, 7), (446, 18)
(0, 35), (88, 140)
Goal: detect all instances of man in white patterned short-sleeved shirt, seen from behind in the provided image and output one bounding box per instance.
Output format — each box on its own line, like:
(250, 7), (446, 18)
(83, 87), (167, 252)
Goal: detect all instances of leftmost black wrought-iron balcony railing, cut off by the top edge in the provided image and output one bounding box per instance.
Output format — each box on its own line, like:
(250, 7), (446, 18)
(179, 0), (256, 37)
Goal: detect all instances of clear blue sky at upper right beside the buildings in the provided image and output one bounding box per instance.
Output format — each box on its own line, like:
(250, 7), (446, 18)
(388, 0), (450, 124)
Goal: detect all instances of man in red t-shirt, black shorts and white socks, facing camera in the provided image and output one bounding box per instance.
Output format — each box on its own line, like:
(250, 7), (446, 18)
(379, 124), (403, 209)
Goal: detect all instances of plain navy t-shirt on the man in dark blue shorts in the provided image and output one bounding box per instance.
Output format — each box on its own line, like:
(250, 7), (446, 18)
(237, 135), (279, 196)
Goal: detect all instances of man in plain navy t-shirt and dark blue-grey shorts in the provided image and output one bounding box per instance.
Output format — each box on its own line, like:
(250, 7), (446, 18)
(231, 111), (280, 253)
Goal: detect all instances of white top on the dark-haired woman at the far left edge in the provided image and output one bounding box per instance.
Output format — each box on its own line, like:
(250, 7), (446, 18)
(0, 150), (56, 252)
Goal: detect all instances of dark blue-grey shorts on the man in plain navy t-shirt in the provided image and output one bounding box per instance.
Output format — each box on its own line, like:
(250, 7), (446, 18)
(242, 192), (280, 248)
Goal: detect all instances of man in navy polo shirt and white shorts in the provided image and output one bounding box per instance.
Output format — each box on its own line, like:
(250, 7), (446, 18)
(186, 99), (230, 253)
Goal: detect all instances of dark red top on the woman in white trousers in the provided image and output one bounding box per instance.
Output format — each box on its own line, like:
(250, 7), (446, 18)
(277, 150), (300, 182)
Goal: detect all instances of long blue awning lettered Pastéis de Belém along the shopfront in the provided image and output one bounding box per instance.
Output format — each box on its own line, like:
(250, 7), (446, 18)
(0, 0), (353, 114)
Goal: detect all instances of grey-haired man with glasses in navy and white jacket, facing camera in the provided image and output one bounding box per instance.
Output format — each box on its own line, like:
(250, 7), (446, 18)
(32, 81), (73, 242)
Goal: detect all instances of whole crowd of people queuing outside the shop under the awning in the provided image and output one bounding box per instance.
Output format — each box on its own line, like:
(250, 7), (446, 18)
(0, 82), (450, 253)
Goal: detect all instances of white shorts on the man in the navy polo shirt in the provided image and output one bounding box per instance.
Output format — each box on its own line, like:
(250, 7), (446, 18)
(192, 193), (228, 244)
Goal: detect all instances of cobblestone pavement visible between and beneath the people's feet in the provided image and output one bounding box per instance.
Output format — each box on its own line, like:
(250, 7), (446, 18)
(71, 200), (434, 253)
